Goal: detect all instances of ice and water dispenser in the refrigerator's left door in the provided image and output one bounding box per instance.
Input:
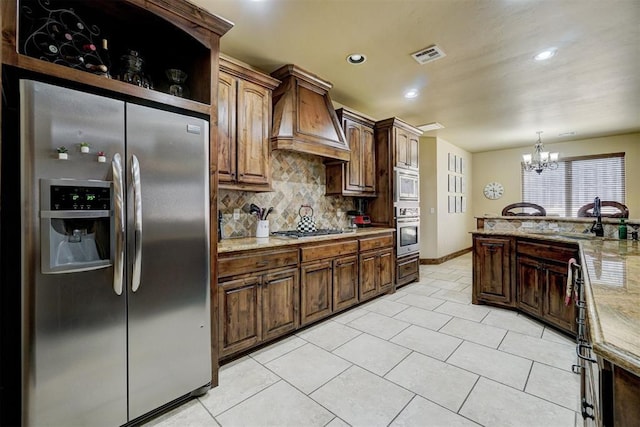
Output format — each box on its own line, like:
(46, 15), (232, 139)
(40, 179), (113, 274)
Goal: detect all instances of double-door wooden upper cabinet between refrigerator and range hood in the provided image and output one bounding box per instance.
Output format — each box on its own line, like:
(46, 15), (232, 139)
(218, 57), (280, 191)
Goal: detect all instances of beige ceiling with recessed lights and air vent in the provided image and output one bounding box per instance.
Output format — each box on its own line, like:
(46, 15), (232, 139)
(191, 0), (640, 152)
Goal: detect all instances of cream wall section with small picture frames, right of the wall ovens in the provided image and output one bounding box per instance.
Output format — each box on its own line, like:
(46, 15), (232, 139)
(420, 137), (475, 259)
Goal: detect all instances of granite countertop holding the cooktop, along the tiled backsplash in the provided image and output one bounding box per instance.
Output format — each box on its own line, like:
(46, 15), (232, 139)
(218, 227), (395, 254)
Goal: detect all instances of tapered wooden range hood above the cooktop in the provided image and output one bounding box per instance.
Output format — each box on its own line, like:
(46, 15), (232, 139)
(271, 64), (350, 161)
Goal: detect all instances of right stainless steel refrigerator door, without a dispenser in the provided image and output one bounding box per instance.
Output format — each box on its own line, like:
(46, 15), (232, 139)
(126, 104), (211, 420)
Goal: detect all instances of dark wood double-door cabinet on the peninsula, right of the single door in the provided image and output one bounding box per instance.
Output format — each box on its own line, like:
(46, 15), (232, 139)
(516, 240), (578, 334)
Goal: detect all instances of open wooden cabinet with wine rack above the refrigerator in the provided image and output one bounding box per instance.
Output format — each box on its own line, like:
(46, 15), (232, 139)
(0, 0), (232, 115)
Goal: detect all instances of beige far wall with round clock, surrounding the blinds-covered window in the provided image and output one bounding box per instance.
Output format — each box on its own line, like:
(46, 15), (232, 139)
(471, 133), (640, 218)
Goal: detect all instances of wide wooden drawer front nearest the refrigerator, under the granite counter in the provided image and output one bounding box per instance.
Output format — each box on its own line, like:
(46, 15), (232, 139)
(218, 249), (298, 277)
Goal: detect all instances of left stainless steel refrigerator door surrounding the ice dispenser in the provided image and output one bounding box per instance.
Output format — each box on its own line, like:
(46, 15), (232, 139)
(20, 80), (127, 426)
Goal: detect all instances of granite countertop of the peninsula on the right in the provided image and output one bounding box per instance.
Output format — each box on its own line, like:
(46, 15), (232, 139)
(473, 230), (640, 376)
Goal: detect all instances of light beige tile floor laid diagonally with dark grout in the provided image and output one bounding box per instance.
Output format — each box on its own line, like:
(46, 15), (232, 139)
(147, 254), (581, 427)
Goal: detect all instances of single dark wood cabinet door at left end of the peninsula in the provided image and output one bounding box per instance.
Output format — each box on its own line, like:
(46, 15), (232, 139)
(473, 237), (513, 306)
